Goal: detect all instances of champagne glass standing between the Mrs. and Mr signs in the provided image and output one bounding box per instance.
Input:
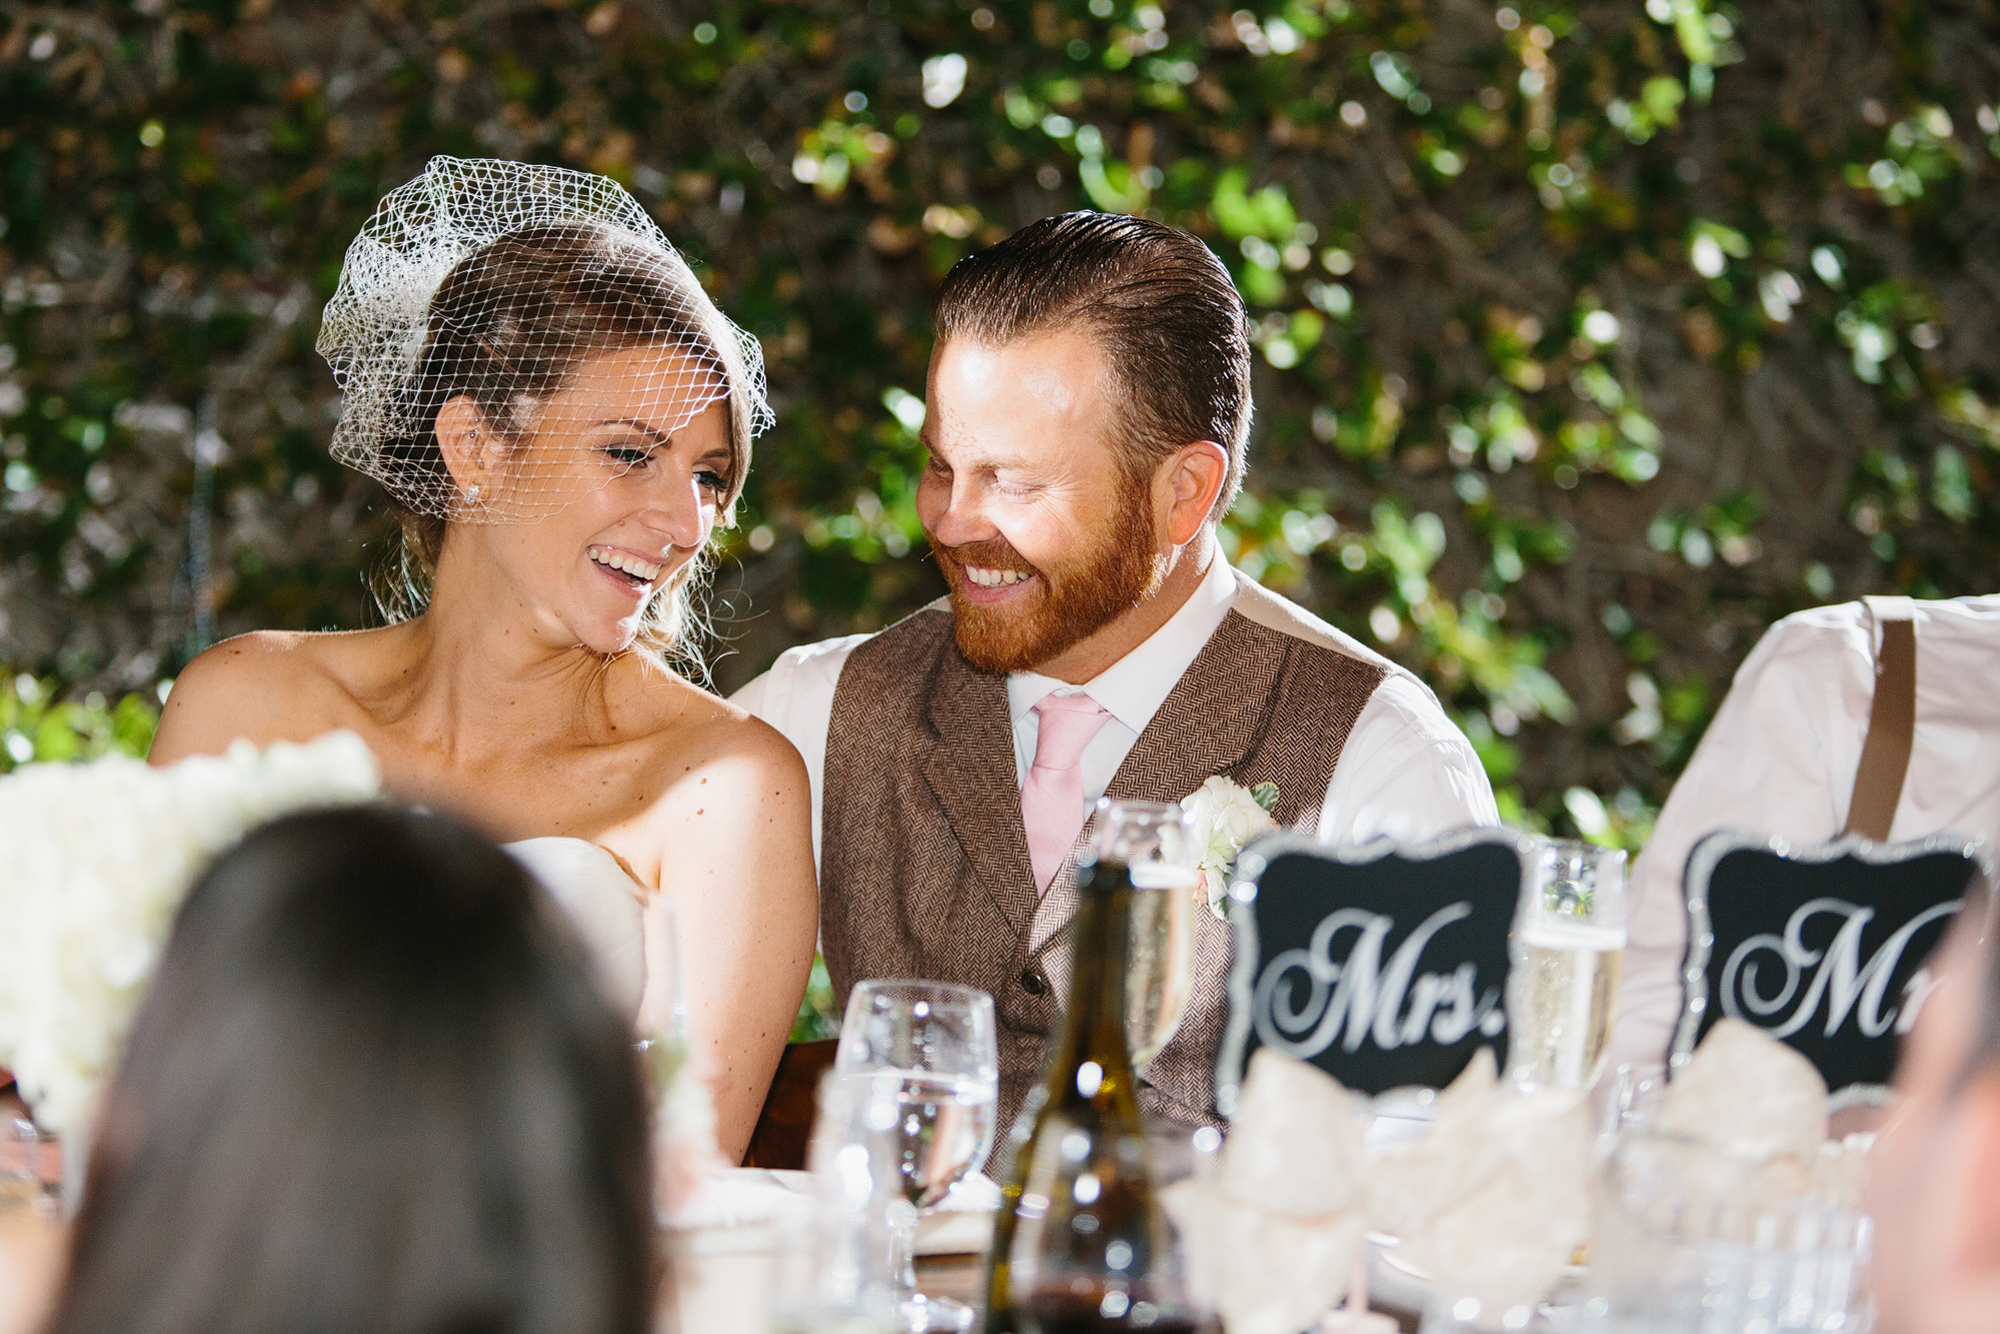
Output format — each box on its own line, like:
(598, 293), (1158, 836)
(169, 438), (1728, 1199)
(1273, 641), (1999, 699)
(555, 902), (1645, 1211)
(1508, 840), (1626, 1090)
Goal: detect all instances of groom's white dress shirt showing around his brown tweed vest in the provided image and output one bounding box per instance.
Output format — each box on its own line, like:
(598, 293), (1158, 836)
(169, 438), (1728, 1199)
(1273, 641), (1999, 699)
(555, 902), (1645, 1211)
(732, 554), (1500, 850)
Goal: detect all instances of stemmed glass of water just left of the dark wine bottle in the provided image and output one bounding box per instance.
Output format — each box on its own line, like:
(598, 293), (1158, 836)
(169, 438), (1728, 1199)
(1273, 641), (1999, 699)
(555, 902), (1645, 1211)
(834, 978), (1000, 1334)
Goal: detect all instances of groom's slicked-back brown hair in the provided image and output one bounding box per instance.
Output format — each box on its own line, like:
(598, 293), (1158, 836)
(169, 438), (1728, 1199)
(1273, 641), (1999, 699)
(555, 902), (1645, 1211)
(936, 212), (1252, 518)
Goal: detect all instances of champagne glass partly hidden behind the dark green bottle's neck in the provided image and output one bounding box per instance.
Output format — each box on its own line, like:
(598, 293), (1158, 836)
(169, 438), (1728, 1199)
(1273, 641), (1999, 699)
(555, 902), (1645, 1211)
(1098, 798), (1206, 1074)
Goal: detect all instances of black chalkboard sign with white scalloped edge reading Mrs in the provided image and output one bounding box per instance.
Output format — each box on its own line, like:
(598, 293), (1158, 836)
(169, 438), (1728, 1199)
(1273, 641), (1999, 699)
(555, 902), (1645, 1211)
(1216, 830), (1532, 1116)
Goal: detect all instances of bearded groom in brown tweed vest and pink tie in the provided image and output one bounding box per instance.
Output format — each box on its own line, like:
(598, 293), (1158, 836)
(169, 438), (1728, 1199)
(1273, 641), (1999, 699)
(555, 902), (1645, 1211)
(736, 212), (1496, 1144)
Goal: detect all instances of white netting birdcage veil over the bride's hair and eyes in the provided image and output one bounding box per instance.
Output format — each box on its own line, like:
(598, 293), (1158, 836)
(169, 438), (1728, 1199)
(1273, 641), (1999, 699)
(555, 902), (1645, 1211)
(318, 156), (772, 522)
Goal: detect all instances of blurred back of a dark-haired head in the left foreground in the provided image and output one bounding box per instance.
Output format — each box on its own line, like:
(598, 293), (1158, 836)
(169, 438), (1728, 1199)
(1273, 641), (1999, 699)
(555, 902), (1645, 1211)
(48, 808), (654, 1334)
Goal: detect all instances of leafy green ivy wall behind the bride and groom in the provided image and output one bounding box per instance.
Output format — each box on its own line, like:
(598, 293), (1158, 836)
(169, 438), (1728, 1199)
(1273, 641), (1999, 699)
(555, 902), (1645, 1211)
(0, 0), (2000, 856)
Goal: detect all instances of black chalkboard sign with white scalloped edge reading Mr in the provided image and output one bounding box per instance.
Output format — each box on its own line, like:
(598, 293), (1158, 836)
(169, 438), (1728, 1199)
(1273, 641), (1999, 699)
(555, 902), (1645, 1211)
(1670, 830), (1980, 1090)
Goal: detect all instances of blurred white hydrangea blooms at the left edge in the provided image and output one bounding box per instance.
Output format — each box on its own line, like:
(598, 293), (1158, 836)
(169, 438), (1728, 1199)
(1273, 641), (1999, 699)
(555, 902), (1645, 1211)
(0, 732), (382, 1134)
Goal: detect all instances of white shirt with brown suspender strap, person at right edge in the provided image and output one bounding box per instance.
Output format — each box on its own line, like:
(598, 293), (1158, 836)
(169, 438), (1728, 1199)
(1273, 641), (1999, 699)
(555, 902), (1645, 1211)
(1612, 596), (2000, 1062)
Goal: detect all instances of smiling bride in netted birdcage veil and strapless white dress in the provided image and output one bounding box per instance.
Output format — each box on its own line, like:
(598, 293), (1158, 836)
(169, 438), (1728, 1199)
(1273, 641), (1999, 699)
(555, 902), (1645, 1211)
(150, 158), (818, 1158)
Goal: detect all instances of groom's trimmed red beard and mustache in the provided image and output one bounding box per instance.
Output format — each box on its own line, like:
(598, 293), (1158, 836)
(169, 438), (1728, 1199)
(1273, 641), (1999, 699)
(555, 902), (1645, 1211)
(930, 486), (1166, 672)
